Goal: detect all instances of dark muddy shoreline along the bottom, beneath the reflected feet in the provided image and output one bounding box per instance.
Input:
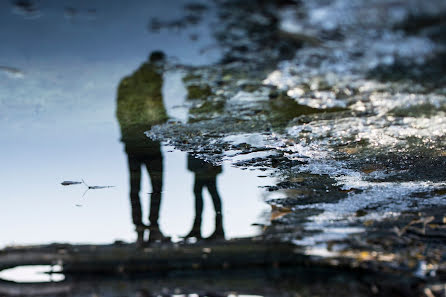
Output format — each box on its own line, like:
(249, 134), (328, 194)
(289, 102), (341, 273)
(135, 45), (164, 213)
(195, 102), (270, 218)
(0, 239), (429, 296)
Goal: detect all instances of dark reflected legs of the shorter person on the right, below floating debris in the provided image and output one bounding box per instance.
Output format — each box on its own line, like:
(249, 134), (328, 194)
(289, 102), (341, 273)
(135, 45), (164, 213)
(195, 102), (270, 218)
(185, 154), (225, 239)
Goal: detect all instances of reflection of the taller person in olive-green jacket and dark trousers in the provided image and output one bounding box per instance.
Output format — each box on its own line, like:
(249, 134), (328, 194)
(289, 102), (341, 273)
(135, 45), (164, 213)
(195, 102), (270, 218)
(116, 51), (167, 244)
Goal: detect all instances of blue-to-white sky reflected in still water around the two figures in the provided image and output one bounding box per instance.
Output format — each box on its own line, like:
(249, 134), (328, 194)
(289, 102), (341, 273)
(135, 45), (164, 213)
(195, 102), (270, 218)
(0, 0), (272, 246)
